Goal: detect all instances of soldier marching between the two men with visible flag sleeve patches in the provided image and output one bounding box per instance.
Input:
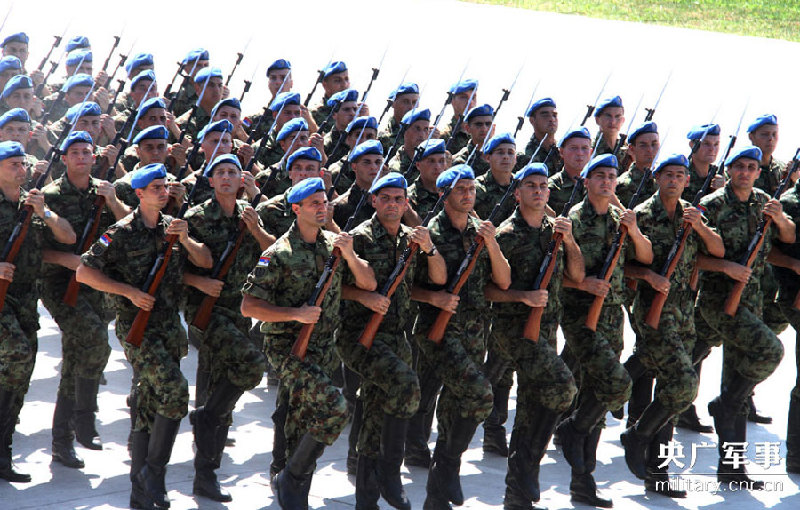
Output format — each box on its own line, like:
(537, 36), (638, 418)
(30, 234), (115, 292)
(183, 154), (275, 501)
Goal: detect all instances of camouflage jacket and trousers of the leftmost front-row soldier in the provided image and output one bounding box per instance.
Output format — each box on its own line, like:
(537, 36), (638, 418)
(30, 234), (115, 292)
(242, 223), (347, 452)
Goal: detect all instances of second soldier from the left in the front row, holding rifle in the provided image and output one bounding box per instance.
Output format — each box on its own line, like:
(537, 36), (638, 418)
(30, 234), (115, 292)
(337, 172), (447, 509)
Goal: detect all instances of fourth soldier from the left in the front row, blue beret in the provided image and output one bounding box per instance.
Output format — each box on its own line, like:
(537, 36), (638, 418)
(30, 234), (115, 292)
(484, 163), (584, 510)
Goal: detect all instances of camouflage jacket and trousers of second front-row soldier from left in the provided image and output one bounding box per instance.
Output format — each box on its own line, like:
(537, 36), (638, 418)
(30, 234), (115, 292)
(337, 215), (420, 458)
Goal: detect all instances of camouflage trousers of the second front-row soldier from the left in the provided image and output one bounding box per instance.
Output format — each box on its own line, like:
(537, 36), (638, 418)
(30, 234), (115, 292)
(337, 332), (420, 458)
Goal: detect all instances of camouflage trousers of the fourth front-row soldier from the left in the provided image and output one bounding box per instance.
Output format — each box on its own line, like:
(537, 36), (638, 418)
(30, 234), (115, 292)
(490, 324), (578, 428)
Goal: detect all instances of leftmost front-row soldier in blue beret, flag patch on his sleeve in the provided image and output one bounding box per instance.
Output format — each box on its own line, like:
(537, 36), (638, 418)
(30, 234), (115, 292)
(242, 178), (377, 509)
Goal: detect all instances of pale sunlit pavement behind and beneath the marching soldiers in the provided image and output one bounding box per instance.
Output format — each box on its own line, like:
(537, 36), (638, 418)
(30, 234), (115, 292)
(0, 0), (800, 510)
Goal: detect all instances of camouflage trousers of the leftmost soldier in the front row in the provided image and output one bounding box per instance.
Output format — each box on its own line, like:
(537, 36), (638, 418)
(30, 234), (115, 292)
(267, 343), (347, 458)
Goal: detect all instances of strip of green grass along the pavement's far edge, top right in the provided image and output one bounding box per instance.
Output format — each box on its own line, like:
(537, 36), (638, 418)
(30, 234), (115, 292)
(466, 0), (800, 41)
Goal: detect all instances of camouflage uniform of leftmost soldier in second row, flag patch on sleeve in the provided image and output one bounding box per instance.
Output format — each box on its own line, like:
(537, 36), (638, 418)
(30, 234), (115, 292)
(81, 208), (189, 431)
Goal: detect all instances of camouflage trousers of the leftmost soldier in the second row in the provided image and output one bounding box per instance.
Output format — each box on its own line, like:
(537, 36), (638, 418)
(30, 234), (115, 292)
(116, 316), (189, 432)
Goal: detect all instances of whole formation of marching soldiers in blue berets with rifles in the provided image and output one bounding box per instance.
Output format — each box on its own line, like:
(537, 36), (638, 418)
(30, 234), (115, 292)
(0, 27), (800, 509)
